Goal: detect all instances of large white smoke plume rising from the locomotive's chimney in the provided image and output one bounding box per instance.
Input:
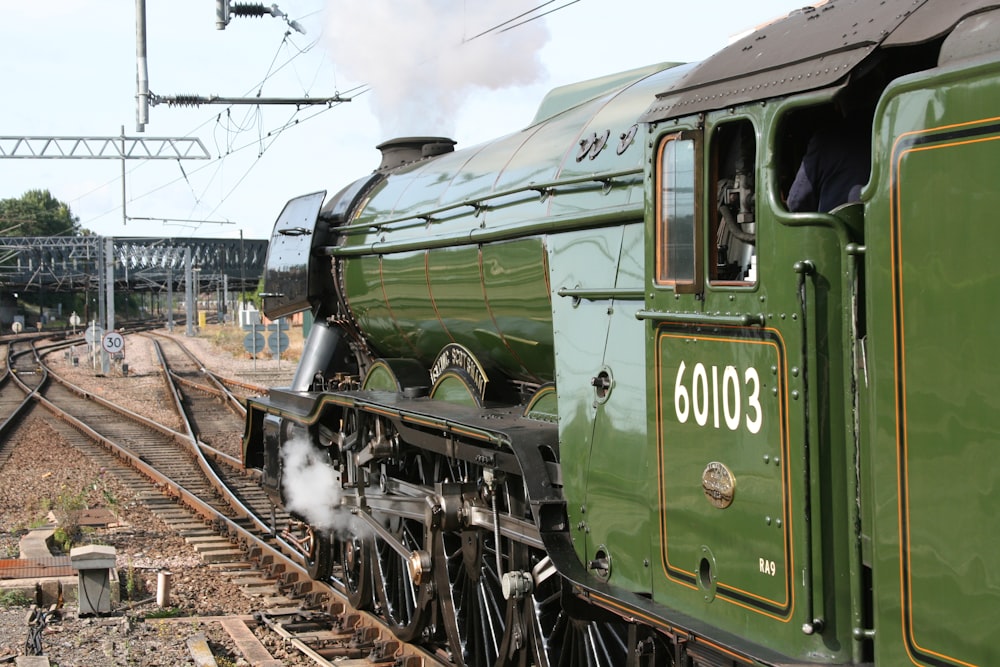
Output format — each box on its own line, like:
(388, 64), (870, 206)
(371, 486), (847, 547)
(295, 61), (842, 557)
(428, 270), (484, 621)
(327, 0), (549, 137)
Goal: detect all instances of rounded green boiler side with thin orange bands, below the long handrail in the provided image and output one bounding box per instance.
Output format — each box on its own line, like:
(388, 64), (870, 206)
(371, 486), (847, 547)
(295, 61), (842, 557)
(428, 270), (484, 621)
(346, 243), (553, 382)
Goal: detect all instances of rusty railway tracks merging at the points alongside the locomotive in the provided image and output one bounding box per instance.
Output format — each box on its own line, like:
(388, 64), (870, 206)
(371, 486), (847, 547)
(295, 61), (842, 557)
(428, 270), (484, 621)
(0, 336), (437, 667)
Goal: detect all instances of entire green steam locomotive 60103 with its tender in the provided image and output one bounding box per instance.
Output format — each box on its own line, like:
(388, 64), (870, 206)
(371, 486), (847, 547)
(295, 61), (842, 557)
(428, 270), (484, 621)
(244, 0), (1000, 667)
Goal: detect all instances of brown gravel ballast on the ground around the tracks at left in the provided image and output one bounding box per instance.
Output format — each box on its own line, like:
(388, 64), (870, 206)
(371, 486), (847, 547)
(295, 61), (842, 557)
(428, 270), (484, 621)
(0, 328), (302, 667)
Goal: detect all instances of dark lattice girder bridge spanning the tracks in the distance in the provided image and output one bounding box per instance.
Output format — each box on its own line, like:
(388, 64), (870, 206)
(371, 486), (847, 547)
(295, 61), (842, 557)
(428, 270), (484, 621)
(0, 236), (268, 326)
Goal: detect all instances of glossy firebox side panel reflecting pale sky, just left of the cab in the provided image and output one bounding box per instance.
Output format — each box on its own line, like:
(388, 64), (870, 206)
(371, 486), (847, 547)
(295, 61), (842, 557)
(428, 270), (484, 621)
(548, 223), (656, 591)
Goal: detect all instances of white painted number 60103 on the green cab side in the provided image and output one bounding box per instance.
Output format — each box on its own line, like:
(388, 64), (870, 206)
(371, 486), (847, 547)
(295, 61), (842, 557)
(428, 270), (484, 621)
(674, 361), (764, 433)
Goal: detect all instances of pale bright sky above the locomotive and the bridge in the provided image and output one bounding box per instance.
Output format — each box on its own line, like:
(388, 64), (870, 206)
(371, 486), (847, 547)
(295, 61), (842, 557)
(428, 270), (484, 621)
(0, 0), (816, 239)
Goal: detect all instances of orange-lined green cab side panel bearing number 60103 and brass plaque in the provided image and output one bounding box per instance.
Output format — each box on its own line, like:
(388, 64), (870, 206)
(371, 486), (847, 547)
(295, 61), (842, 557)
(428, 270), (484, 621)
(654, 325), (793, 618)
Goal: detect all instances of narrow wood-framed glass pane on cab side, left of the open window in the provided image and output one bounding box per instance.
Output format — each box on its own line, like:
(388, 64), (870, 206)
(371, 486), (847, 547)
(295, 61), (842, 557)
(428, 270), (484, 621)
(656, 132), (701, 293)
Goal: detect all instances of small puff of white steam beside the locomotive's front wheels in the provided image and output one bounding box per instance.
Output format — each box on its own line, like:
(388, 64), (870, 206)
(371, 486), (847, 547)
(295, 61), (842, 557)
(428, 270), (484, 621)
(281, 437), (351, 531)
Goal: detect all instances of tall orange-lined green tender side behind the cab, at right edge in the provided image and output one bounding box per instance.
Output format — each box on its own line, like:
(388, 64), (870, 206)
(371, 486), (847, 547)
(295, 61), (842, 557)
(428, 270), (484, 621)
(866, 64), (1000, 665)
